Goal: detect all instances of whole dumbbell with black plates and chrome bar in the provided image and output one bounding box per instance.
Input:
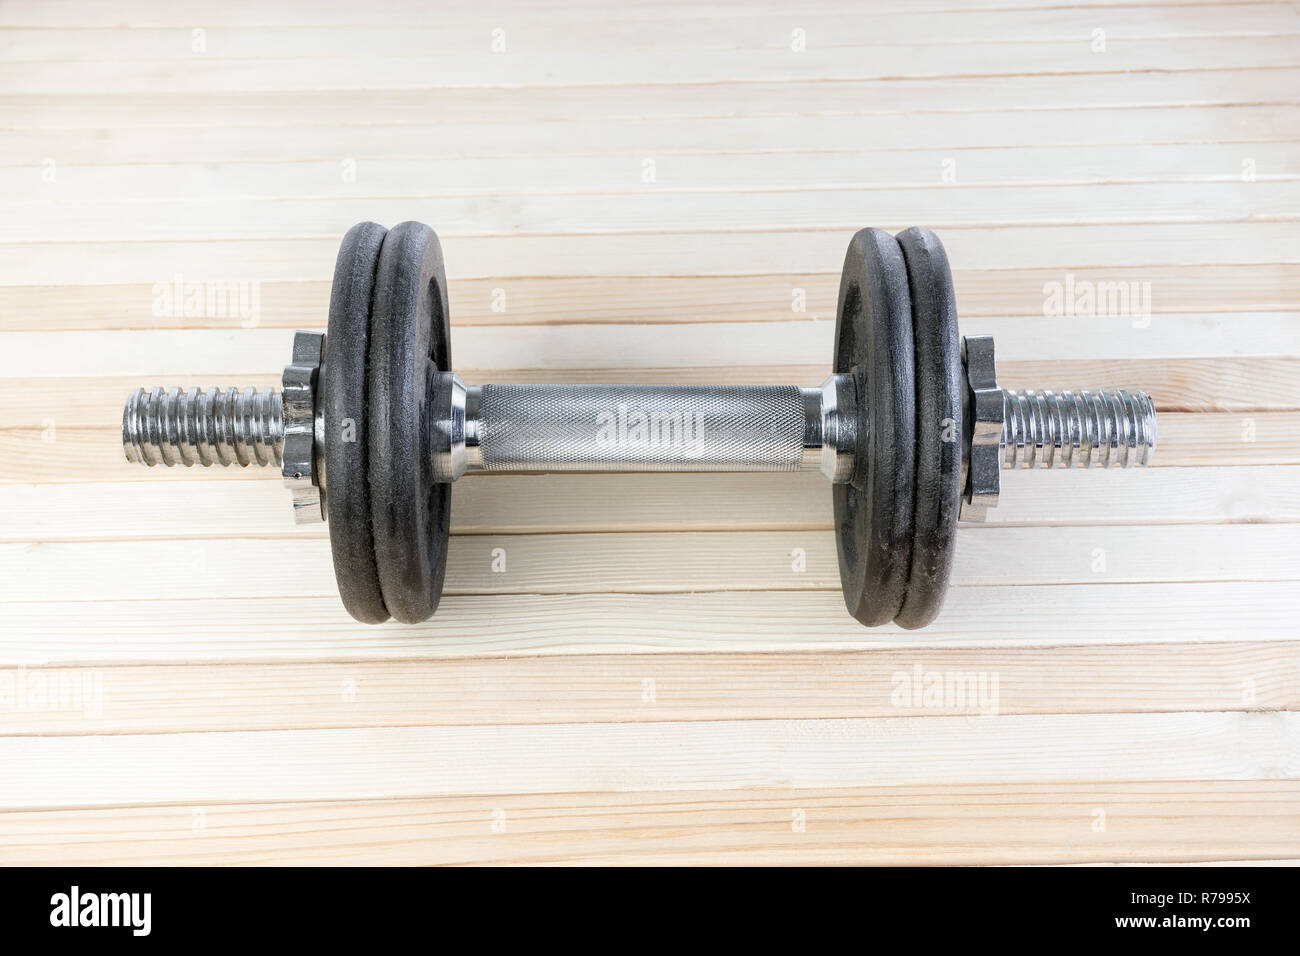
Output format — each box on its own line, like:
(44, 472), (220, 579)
(122, 222), (1156, 628)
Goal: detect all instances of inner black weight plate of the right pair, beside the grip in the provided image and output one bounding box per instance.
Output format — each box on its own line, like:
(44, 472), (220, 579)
(832, 229), (917, 626)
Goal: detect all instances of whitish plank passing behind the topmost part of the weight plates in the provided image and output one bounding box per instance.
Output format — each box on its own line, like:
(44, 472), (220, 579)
(0, 226), (1300, 286)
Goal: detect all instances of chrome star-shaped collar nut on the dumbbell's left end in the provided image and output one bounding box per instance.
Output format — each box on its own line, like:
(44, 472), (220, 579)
(280, 330), (325, 524)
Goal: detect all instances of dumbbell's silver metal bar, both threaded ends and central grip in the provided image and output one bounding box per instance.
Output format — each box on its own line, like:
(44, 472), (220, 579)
(122, 376), (1156, 481)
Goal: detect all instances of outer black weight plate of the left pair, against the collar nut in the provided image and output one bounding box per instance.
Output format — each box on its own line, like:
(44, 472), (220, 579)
(317, 222), (389, 624)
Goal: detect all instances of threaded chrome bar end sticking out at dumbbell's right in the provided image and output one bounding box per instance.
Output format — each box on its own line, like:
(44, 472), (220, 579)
(1002, 389), (1156, 468)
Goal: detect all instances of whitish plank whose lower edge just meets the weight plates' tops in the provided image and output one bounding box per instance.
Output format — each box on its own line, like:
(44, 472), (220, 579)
(12, 180), (1300, 246)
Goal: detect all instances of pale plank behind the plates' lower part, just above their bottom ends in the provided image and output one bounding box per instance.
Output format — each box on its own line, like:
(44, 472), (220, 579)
(0, 524), (1300, 602)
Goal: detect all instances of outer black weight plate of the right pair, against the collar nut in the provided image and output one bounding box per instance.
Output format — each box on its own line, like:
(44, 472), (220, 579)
(894, 226), (962, 628)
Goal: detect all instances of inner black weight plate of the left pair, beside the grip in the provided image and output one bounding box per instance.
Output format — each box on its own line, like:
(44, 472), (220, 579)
(368, 222), (451, 624)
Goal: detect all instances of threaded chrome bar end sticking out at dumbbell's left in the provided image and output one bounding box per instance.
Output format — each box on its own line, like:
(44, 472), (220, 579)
(122, 388), (285, 467)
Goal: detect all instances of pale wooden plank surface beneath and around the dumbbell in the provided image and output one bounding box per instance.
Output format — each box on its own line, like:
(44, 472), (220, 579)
(0, 0), (1300, 864)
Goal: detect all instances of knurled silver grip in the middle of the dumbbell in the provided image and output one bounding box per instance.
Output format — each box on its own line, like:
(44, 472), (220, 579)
(468, 385), (820, 471)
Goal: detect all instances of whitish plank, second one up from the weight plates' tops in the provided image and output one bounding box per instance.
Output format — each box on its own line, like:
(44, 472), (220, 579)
(10, 142), (1300, 203)
